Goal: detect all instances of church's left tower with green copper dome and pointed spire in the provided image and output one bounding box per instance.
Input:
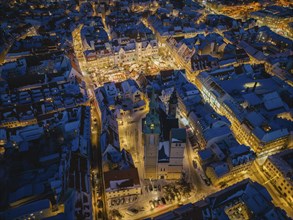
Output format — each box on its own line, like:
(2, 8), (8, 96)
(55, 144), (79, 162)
(143, 90), (161, 179)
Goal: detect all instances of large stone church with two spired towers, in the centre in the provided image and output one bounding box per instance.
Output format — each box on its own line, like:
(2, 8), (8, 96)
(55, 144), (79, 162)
(143, 89), (186, 179)
